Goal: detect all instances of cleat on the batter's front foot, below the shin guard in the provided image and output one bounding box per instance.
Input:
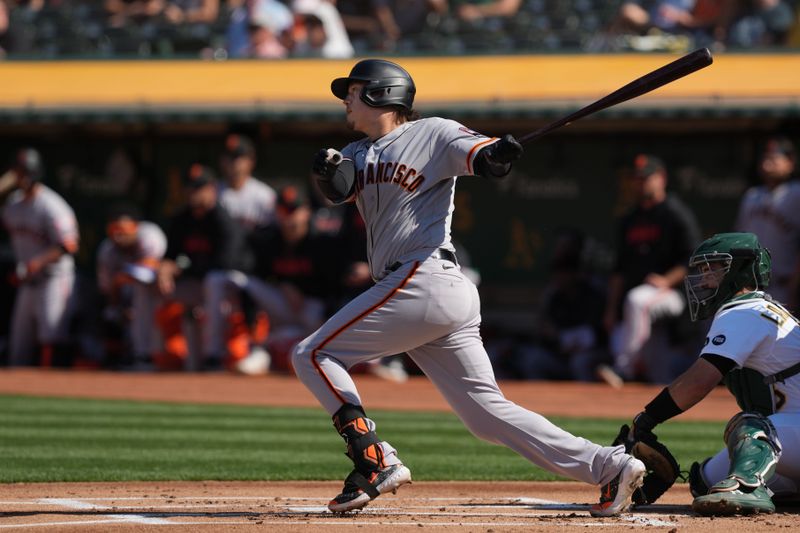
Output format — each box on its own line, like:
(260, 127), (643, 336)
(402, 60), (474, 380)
(328, 464), (411, 513)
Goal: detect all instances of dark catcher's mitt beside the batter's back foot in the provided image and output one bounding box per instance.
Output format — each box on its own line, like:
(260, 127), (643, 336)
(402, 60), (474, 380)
(613, 424), (681, 505)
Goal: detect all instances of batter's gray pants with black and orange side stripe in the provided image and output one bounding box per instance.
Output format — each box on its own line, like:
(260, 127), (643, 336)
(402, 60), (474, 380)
(292, 258), (627, 484)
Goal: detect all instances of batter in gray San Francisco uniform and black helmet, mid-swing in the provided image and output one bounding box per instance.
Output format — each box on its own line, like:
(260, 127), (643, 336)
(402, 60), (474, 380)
(292, 59), (645, 516)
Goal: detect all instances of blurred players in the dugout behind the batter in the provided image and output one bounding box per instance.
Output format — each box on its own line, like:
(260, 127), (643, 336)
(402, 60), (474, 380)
(0, 134), (800, 387)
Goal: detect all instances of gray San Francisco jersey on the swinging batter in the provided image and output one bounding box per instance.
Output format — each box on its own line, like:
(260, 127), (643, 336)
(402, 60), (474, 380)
(342, 117), (495, 280)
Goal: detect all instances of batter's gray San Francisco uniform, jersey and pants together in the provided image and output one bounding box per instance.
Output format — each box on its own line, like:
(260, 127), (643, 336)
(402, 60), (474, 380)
(292, 118), (629, 484)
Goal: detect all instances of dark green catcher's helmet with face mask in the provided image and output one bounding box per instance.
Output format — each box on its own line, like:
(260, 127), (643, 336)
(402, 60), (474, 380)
(686, 233), (772, 320)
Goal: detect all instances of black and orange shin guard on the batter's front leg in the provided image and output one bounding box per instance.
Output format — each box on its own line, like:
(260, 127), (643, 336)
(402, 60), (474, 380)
(333, 403), (386, 475)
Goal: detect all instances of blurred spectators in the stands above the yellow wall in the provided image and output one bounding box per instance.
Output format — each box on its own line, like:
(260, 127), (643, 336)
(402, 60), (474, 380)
(0, 0), (800, 60)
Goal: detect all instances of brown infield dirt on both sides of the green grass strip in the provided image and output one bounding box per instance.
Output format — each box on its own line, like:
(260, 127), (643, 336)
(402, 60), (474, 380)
(0, 370), (800, 533)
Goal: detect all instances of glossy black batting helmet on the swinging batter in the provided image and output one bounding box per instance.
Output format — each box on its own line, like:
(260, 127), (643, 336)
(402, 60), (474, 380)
(331, 59), (417, 110)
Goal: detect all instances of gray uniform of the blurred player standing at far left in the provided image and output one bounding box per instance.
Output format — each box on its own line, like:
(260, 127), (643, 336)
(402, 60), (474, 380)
(3, 184), (78, 366)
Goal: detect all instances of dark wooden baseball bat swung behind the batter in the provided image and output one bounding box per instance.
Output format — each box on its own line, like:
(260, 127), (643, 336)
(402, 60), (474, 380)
(517, 48), (714, 143)
